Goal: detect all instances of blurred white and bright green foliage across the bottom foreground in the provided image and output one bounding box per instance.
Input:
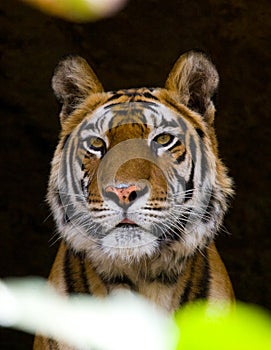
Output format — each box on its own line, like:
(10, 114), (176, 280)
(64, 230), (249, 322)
(0, 278), (271, 350)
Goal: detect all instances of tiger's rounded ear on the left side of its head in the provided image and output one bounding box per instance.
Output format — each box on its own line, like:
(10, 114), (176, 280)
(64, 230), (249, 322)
(52, 56), (103, 121)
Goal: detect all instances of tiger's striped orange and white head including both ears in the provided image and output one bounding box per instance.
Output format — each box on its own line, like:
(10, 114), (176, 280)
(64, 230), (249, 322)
(48, 51), (232, 261)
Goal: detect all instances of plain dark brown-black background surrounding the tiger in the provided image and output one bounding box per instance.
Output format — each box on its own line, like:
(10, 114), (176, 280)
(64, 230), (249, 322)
(0, 0), (271, 349)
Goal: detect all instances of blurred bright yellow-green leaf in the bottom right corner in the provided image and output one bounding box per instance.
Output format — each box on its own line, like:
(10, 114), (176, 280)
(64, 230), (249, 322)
(175, 302), (271, 350)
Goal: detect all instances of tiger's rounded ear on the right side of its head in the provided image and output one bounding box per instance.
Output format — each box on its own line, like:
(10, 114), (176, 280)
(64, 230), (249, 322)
(166, 51), (219, 123)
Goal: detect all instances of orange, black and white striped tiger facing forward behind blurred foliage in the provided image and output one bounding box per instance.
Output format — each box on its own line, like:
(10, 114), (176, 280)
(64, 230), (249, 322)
(34, 50), (234, 350)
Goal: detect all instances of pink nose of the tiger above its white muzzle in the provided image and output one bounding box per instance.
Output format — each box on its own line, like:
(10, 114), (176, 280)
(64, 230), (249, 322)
(104, 184), (146, 206)
